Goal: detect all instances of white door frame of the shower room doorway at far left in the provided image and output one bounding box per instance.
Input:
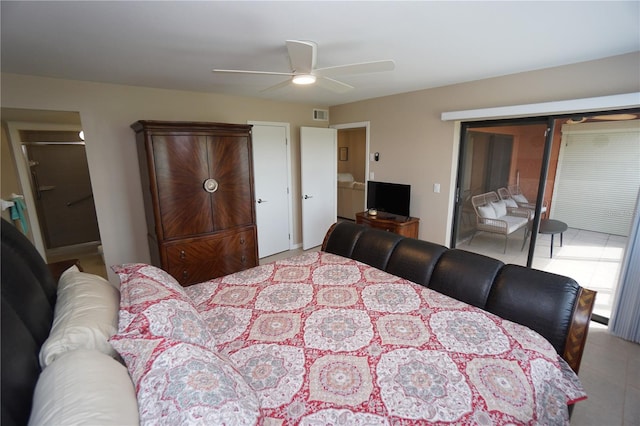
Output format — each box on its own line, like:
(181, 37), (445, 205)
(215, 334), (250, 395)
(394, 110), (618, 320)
(7, 121), (84, 259)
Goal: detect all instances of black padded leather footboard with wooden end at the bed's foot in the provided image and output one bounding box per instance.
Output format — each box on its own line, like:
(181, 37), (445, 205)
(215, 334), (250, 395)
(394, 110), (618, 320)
(322, 222), (595, 373)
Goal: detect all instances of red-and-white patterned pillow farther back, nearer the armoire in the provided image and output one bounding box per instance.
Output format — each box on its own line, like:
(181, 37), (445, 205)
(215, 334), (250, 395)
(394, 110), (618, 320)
(112, 263), (215, 349)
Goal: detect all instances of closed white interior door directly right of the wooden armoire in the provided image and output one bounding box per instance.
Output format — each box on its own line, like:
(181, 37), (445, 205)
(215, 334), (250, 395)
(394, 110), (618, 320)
(252, 123), (291, 258)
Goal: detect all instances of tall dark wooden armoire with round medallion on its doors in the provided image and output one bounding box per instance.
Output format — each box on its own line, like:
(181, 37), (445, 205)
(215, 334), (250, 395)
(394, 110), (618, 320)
(131, 120), (258, 286)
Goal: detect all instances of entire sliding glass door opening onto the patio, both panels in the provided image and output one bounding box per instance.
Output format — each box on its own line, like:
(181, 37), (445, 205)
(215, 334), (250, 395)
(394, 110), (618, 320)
(451, 109), (640, 323)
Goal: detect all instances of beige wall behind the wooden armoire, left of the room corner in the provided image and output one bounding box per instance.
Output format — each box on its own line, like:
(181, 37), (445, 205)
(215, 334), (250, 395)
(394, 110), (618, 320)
(1, 74), (318, 279)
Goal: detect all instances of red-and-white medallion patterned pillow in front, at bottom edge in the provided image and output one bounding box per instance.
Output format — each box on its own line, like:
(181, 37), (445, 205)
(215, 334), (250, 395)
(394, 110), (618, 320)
(111, 335), (260, 425)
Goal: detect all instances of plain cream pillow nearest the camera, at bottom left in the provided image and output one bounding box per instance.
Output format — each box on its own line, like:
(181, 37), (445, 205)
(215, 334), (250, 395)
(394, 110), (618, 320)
(29, 349), (138, 425)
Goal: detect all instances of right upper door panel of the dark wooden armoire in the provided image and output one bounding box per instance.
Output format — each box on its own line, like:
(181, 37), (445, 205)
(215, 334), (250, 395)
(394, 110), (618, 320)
(209, 136), (255, 229)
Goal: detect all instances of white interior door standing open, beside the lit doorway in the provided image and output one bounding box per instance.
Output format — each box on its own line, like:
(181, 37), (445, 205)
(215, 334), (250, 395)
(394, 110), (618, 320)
(300, 127), (338, 250)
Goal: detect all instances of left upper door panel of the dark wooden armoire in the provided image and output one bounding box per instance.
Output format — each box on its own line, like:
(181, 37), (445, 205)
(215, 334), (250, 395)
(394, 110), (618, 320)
(152, 135), (213, 238)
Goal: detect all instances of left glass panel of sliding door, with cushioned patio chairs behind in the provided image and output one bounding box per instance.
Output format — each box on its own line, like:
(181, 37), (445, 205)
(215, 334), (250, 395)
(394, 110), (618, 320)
(452, 119), (553, 265)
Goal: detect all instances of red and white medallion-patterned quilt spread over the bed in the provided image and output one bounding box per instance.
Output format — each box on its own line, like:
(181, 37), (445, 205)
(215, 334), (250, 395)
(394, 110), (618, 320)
(185, 252), (586, 425)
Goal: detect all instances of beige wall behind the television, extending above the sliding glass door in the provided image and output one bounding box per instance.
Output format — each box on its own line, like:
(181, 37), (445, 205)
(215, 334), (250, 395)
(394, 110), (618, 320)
(330, 53), (640, 245)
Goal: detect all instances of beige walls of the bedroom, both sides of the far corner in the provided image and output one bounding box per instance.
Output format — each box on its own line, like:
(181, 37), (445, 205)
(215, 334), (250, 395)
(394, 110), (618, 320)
(1, 54), (640, 278)
